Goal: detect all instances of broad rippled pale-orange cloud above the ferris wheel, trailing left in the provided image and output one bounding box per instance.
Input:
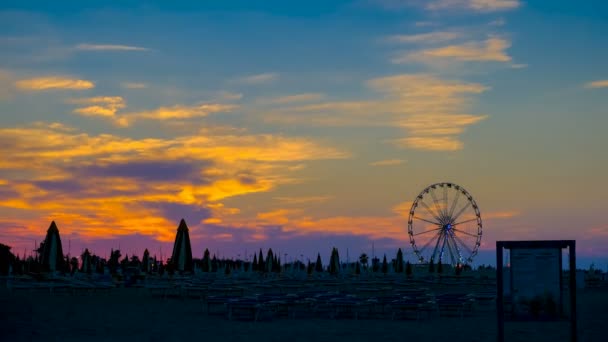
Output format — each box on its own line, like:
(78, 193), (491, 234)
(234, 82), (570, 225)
(265, 74), (489, 151)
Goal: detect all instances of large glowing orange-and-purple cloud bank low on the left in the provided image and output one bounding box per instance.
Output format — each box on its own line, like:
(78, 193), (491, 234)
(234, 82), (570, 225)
(0, 123), (349, 246)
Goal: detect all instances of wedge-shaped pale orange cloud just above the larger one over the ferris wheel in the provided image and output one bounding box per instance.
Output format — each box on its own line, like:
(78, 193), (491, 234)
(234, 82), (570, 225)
(400, 37), (511, 64)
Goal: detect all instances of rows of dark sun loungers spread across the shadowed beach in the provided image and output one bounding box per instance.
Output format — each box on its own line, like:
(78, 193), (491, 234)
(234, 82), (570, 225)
(4, 277), (496, 321)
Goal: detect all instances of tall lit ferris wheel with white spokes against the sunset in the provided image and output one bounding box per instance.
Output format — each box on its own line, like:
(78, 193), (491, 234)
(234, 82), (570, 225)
(407, 183), (482, 266)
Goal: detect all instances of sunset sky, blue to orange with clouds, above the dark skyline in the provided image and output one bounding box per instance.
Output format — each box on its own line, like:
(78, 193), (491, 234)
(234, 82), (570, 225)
(0, 0), (608, 268)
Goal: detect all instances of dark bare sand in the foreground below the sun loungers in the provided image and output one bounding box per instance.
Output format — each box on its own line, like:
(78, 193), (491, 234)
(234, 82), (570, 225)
(0, 288), (608, 342)
